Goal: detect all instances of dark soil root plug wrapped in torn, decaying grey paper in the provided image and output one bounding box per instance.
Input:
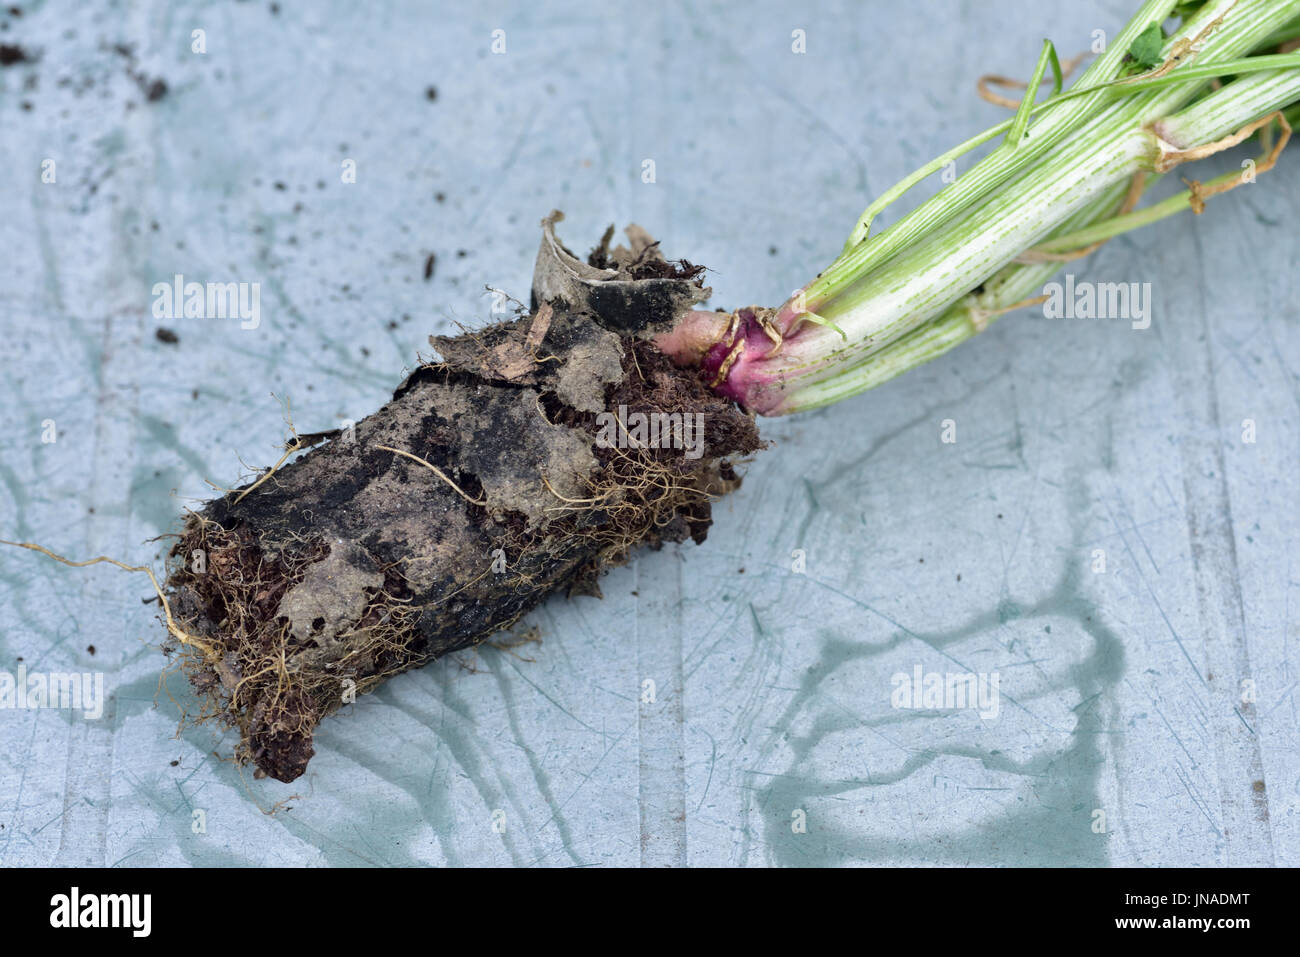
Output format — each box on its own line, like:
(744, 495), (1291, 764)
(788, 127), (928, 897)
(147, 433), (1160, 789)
(166, 215), (762, 781)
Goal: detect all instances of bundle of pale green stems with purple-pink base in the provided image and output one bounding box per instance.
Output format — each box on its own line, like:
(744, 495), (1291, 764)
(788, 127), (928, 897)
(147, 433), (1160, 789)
(681, 0), (1300, 415)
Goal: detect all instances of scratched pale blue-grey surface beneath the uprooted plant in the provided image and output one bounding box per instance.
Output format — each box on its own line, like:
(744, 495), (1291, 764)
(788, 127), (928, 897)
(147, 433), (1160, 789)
(0, 0), (1300, 866)
